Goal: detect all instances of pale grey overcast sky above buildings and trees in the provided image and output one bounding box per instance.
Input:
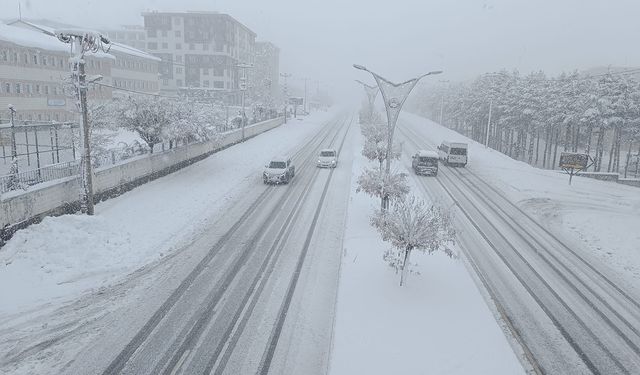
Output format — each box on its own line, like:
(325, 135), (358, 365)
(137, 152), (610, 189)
(12, 0), (640, 101)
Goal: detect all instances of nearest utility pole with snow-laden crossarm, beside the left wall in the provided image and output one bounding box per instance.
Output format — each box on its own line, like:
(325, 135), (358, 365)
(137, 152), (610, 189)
(55, 29), (110, 215)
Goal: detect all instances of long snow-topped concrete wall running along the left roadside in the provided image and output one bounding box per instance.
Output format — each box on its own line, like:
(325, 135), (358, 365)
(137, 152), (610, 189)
(0, 118), (283, 246)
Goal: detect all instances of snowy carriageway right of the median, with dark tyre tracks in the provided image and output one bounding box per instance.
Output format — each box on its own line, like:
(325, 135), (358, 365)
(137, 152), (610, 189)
(399, 122), (640, 374)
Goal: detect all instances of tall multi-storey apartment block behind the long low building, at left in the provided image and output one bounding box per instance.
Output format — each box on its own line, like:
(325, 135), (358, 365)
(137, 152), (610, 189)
(142, 12), (256, 102)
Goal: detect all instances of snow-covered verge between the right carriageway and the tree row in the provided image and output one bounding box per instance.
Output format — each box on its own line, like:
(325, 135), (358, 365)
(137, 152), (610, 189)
(400, 114), (640, 289)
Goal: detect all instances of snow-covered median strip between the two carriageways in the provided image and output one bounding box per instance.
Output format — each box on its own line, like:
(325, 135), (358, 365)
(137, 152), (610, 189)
(330, 129), (523, 375)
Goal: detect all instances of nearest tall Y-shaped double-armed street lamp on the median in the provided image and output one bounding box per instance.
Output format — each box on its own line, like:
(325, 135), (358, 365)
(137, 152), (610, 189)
(353, 64), (442, 210)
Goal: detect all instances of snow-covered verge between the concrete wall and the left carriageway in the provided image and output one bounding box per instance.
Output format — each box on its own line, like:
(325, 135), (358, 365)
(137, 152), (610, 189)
(0, 112), (334, 317)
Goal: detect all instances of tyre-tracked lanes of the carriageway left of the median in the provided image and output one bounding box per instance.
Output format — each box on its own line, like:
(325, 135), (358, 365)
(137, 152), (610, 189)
(70, 117), (352, 374)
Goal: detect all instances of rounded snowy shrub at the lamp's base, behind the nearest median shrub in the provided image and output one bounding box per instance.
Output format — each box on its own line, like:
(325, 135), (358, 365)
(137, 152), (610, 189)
(356, 167), (409, 209)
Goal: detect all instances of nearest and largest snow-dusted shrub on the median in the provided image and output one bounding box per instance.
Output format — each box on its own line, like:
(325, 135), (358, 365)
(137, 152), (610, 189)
(371, 196), (455, 286)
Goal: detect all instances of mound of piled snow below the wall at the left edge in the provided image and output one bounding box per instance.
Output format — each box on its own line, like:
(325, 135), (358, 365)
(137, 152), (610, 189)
(0, 215), (134, 313)
